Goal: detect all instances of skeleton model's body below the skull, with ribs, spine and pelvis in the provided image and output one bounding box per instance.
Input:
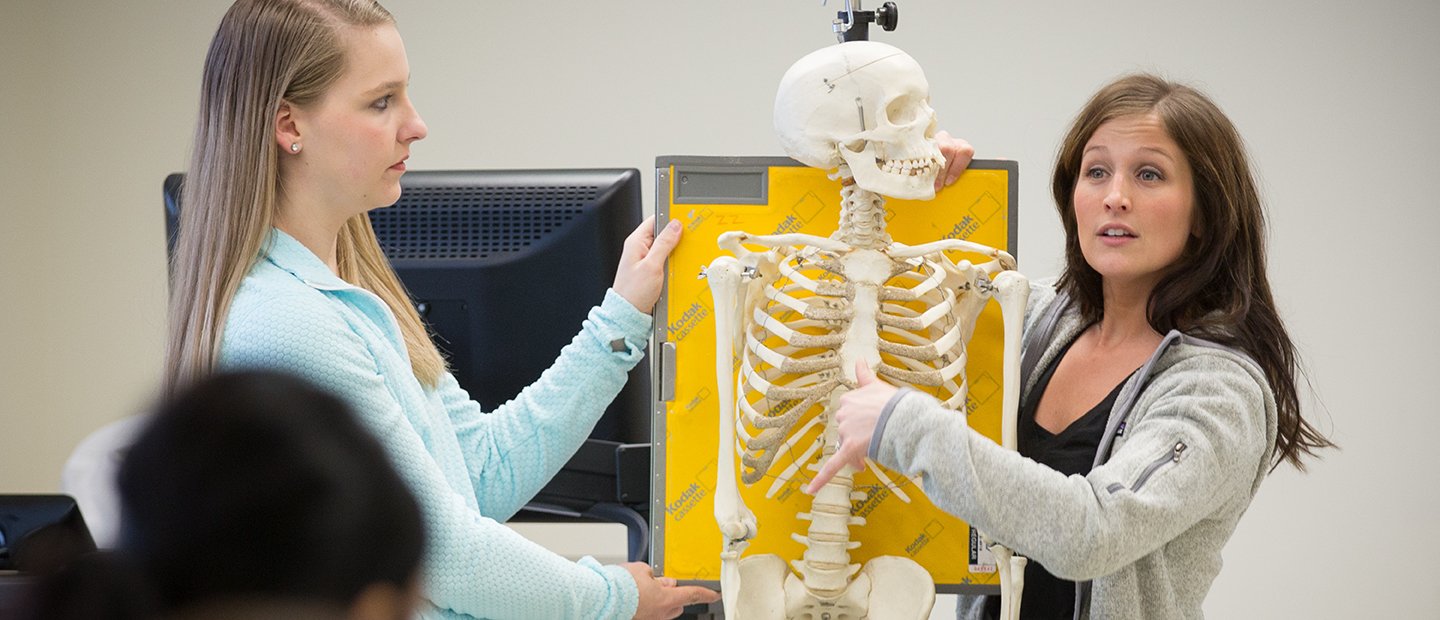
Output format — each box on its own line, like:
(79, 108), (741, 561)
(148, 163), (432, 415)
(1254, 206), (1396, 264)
(706, 179), (1024, 617)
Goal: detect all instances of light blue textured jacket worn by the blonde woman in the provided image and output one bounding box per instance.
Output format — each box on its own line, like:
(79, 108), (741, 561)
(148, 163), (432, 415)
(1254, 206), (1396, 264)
(219, 230), (651, 619)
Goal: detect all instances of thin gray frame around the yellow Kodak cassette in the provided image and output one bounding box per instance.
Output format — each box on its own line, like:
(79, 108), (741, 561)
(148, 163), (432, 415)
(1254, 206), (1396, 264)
(649, 155), (1020, 594)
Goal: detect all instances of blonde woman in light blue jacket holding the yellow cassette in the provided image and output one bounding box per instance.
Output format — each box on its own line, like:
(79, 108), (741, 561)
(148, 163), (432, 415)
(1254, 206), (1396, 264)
(166, 0), (717, 619)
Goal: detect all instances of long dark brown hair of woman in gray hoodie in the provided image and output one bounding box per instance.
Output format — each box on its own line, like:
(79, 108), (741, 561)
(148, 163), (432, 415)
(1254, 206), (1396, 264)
(1051, 73), (1333, 470)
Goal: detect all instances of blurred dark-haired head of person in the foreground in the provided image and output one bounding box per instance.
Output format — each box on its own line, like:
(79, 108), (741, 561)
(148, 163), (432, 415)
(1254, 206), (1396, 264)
(94, 373), (425, 617)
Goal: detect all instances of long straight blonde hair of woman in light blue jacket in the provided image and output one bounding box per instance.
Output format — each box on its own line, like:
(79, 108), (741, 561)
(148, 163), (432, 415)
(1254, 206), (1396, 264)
(166, 0), (445, 394)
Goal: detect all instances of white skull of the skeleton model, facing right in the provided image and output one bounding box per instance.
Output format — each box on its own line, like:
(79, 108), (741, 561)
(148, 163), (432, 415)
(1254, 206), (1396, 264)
(775, 40), (945, 200)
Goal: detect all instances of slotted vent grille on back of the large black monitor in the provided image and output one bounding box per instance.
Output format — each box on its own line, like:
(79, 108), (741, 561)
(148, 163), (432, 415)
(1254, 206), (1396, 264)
(370, 186), (599, 260)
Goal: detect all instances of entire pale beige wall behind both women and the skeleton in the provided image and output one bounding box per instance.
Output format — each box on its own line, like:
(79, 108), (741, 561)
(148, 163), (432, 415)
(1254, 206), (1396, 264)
(0, 0), (1440, 619)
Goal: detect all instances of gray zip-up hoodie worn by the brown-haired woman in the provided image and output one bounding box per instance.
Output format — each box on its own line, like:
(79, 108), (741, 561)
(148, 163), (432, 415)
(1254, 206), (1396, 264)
(870, 285), (1276, 619)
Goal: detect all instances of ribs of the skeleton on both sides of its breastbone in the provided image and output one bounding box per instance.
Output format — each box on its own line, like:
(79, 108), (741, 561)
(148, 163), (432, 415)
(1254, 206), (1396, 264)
(736, 246), (984, 495)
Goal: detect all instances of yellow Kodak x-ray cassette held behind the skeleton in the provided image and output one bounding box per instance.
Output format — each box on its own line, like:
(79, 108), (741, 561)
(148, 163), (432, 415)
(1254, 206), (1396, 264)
(651, 157), (1018, 594)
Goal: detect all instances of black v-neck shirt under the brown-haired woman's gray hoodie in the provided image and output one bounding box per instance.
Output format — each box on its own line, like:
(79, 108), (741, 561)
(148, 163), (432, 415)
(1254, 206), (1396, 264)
(985, 341), (1129, 620)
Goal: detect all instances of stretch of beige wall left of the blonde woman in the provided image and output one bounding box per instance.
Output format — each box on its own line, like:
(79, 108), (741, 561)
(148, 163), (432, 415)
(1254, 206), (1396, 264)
(0, 0), (223, 492)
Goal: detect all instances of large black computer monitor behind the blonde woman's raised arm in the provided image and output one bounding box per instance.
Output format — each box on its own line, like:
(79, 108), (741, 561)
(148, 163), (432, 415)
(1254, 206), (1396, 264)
(164, 168), (649, 480)
